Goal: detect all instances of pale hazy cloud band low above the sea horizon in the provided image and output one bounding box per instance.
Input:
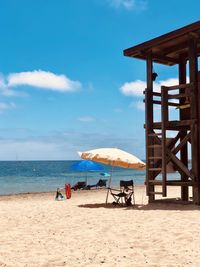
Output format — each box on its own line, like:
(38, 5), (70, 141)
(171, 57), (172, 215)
(0, 128), (144, 160)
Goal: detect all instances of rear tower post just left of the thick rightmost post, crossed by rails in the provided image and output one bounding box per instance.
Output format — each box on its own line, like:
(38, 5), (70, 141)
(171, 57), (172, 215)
(179, 57), (190, 201)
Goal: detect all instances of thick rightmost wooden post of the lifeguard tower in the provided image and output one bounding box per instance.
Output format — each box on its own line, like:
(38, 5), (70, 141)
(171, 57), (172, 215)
(189, 37), (200, 205)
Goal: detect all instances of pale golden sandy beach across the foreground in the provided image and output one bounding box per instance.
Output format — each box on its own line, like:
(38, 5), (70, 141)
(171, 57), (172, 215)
(0, 186), (200, 267)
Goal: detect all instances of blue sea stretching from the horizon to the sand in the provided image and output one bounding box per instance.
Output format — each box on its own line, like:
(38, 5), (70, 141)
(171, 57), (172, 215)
(0, 160), (180, 195)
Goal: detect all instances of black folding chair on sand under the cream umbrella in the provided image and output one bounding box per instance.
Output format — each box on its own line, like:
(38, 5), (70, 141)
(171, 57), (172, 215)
(110, 180), (135, 206)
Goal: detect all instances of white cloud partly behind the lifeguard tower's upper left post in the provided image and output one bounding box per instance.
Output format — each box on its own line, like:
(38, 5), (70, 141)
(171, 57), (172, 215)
(120, 78), (184, 97)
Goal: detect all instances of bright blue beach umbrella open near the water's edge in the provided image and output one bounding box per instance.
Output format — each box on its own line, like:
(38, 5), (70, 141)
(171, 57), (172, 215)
(70, 160), (104, 185)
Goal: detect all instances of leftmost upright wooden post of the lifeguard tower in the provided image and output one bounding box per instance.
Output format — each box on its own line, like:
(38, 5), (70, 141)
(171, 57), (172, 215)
(145, 52), (155, 202)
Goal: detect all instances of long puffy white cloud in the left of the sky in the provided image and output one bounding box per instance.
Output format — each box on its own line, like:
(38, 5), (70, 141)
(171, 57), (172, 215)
(7, 70), (81, 92)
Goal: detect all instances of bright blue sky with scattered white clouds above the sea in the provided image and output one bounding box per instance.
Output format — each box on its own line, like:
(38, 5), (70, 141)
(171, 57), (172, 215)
(0, 0), (200, 160)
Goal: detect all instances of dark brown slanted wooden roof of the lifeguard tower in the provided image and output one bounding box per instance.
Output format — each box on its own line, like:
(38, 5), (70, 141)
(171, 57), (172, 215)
(124, 21), (200, 66)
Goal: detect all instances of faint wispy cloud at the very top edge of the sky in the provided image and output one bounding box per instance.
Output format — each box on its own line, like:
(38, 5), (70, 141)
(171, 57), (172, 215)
(108, 0), (147, 10)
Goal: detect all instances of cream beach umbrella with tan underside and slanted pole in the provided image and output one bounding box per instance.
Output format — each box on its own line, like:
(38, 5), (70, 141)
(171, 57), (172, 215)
(79, 148), (145, 203)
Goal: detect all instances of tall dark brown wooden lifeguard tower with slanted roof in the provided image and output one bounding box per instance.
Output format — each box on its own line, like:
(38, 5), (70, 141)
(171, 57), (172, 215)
(124, 21), (200, 205)
